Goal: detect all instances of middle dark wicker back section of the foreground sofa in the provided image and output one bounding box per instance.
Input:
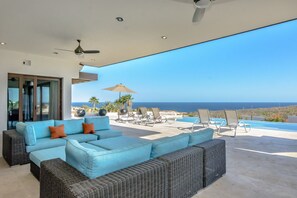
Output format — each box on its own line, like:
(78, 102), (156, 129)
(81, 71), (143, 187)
(158, 147), (203, 198)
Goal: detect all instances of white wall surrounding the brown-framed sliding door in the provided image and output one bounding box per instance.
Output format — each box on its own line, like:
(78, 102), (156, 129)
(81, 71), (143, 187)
(0, 50), (79, 156)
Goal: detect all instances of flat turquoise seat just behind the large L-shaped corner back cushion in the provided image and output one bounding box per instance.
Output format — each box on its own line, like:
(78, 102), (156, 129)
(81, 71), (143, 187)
(88, 136), (150, 150)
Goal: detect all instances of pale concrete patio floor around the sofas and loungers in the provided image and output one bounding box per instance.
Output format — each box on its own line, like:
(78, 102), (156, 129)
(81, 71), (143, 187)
(0, 121), (297, 198)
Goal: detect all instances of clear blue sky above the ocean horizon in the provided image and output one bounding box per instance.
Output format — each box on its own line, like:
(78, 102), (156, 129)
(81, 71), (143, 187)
(72, 20), (297, 102)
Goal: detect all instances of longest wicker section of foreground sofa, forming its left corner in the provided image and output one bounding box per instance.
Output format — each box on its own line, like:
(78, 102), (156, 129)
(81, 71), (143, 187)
(40, 159), (168, 198)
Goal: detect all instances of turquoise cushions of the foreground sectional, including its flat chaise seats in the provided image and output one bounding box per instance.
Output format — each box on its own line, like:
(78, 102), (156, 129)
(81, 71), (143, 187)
(29, 128), (214, 179)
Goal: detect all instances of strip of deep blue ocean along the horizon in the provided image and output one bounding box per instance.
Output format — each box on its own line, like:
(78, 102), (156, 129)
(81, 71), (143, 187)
(72, 102), (297, 112)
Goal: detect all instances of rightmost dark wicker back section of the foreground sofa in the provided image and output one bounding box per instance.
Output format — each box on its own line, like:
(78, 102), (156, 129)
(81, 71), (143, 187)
(195, 139), (226, 187)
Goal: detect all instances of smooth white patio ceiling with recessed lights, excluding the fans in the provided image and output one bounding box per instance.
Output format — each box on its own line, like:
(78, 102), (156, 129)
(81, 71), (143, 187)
(0, 0), (297, 66)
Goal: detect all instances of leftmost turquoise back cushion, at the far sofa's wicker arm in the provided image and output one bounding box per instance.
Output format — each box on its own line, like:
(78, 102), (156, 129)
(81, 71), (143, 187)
(16, 122), (36, 146)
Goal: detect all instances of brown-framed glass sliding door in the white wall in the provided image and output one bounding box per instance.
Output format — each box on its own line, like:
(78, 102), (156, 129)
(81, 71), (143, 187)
(7, 74), (62, 129)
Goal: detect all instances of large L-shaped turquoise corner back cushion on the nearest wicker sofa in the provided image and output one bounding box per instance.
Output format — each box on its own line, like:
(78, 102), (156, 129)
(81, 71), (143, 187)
(66, 140), (152, 179)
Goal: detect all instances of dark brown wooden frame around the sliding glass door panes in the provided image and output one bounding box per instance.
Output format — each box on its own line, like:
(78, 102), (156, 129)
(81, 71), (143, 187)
(6, 73), (63, 124)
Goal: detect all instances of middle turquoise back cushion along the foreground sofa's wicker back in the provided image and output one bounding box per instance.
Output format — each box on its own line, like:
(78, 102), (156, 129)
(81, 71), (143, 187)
(151, 134), (189, 158)
